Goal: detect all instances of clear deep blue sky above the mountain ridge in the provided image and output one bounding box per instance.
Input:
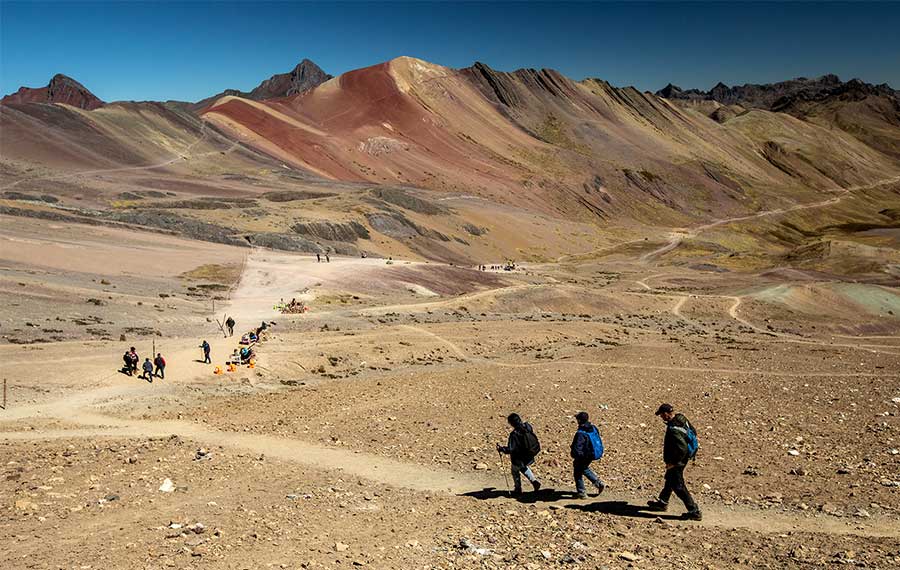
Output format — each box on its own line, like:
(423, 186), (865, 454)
(0, 0), (900, 101)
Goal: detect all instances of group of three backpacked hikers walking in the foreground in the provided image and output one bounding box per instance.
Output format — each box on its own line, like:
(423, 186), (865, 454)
(497, 404), (703, 521)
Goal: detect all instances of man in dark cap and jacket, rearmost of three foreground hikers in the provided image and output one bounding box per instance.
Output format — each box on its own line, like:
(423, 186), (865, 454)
(647, 404), (703, 521)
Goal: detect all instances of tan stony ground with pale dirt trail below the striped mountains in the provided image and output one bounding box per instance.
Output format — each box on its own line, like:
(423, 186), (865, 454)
(0, 224), (900, 569)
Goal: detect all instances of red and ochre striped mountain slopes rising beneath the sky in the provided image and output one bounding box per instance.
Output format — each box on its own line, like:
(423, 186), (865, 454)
(0, 57), (900, 265)
